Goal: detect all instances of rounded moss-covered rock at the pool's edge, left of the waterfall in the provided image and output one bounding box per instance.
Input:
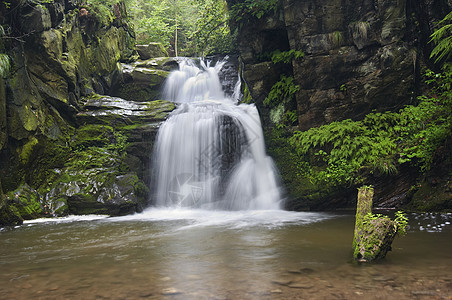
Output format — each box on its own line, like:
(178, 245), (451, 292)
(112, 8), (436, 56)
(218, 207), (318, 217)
(46, 146), (147, 215)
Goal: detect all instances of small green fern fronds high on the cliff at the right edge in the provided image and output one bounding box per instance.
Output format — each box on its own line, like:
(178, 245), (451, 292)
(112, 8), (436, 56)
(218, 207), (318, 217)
(430, 12), (452, 62)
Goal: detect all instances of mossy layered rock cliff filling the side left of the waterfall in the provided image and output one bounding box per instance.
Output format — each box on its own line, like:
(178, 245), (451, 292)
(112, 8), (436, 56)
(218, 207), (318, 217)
(0, 0), (174, 225)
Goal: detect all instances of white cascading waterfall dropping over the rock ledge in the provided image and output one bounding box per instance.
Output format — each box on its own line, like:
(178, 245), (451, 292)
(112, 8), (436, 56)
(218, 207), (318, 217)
(153, 60), (280, 210)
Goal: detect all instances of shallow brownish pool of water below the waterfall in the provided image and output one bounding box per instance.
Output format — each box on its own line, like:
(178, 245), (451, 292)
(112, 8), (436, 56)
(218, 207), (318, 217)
(0, 209), (452, 299)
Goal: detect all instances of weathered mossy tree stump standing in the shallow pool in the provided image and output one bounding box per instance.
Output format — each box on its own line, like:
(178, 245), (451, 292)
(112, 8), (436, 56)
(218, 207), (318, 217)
(353, 186), (398, 262)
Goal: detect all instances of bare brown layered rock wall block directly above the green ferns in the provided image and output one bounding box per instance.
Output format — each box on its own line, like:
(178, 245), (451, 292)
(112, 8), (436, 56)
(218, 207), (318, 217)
(284, 1), (417, 129)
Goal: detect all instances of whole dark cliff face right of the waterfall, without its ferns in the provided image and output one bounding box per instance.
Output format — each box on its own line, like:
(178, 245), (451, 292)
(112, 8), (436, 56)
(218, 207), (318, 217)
(228, 0), (451, 209)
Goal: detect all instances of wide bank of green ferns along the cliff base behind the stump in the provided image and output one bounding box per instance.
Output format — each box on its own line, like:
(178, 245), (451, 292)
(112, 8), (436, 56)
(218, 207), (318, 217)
(289, 68), (452, 186)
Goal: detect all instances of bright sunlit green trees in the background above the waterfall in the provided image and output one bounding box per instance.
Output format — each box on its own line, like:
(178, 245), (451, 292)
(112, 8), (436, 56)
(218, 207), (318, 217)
(127, 0), (235, 56)
